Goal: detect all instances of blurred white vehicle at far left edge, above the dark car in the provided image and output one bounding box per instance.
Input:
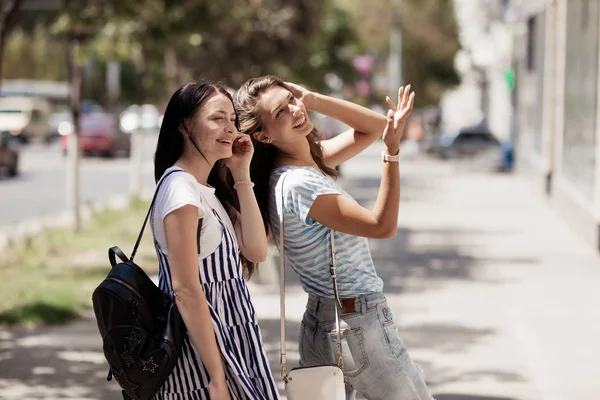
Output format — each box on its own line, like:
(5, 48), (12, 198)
(0, 96), (52, 143)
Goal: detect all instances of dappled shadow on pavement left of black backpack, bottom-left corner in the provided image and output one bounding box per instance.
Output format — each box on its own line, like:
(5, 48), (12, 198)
(0, 315), (120, 400)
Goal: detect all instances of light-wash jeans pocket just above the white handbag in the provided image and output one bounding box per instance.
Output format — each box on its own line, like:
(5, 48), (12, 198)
(327, 328), (369, 378)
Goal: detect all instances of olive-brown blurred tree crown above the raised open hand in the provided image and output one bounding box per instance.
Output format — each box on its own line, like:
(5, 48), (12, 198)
(338, 0), (460, 106)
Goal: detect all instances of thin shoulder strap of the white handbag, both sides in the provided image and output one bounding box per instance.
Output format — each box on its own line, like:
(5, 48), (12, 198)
(279, 170), (343, 381)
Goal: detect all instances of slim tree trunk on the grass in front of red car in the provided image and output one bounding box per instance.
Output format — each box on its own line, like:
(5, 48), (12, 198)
(66, 40), (83, 231)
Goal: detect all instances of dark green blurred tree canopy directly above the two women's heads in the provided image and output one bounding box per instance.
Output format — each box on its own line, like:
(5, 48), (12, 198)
(123, 0), (356, 97)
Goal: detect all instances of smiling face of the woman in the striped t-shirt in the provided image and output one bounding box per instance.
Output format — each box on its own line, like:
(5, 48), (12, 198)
(255, 86), (313, 144)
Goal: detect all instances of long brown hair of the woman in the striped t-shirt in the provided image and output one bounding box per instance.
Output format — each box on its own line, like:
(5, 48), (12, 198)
(234, 75), (337, 235)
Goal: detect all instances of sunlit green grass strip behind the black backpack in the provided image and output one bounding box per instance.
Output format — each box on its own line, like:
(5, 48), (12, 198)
(0, 200), (157, 324)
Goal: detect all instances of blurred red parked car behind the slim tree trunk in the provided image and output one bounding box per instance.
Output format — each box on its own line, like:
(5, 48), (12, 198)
(61, 112), (131, 157)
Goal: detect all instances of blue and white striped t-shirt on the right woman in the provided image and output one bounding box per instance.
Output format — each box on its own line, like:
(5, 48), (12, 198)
(269, 166), (383, 298)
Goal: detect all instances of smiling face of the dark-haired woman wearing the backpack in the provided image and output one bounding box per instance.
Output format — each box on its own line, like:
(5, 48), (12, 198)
(189, 92), (238, 162)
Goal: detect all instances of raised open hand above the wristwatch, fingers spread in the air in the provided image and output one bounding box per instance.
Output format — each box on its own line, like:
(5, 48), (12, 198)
(383, 85), (415, 155)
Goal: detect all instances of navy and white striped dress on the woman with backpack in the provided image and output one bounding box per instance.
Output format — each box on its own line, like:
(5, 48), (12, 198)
(155, 210), (279, 400)
